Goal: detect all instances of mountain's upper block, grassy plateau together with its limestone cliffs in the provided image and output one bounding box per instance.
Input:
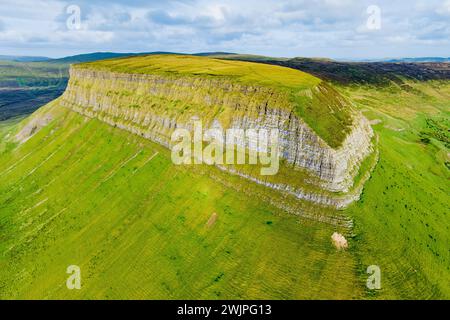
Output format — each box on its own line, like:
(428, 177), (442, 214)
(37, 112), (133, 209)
(59, 55), (374, 208)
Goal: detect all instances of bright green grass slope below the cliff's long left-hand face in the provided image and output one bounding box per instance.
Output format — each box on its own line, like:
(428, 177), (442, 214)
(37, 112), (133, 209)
(0, 101), (358, 299)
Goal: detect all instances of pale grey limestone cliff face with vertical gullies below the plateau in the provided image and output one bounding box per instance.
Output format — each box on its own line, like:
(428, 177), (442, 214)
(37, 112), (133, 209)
(61, 66), (374, 207)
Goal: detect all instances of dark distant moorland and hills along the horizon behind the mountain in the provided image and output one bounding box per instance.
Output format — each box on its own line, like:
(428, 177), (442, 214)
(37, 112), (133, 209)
(0, 51), (450, 121)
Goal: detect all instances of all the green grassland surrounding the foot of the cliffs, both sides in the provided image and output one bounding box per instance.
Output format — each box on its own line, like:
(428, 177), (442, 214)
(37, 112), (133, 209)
(0, 63), (450, 299)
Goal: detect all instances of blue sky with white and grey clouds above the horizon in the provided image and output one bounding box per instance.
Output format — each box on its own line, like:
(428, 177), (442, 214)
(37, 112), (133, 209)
(0, 0), (450, 60)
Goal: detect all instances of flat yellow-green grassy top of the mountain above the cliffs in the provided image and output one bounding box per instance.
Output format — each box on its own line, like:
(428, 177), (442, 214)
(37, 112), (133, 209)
(71, 55), (352, 147)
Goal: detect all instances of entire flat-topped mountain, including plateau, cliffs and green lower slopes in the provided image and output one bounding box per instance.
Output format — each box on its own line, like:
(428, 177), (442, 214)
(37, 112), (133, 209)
(0, 55), (450, 299)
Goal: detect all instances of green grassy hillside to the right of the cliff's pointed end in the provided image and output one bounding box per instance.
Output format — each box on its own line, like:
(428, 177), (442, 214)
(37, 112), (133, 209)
(342, 81), (450, 299)
